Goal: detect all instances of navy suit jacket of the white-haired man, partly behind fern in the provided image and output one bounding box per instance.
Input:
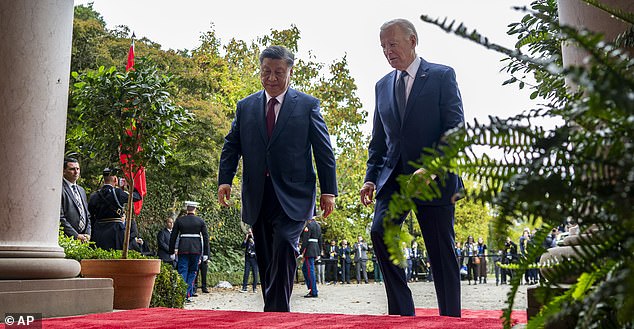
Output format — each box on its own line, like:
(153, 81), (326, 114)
(365, 59), (464, 205)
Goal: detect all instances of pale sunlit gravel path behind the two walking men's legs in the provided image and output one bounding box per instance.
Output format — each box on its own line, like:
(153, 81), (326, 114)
(185, 280), (526, 315)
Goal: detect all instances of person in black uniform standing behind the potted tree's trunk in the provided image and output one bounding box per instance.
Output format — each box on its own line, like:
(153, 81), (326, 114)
(88, 168), (143, 250)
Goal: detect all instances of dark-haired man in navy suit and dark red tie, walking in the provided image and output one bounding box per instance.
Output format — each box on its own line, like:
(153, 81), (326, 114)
(218, 46), (337, 312)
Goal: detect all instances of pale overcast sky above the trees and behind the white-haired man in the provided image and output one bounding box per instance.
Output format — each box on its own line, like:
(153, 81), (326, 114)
(75, 0), (534, 133)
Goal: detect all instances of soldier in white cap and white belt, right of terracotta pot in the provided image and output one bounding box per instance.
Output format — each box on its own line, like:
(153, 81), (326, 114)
(169, 201), (209, 302)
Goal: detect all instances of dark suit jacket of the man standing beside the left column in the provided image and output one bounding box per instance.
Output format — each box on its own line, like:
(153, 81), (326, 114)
(59, 180), (91, 238)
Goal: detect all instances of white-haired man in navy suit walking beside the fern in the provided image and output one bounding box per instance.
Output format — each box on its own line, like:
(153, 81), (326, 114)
(360, 19), (464, 317)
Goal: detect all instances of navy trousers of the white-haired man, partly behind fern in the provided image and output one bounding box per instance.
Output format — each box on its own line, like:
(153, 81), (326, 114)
(370, 197), (461, 317)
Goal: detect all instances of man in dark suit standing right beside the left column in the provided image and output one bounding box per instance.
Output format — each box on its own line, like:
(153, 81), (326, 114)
(59, 158), (92, 242)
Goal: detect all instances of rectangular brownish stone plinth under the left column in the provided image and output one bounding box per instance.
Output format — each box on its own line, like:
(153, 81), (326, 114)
(0, 278), (114, 318)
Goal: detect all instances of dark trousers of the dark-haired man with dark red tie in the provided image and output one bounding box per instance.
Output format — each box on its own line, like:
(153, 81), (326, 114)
(253, 177), (305, 312)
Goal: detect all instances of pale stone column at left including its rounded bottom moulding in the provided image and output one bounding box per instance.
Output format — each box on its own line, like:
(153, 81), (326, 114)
(0, 0), (79, 280)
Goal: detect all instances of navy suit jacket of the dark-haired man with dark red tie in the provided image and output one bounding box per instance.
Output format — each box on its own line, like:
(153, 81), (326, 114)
(218, 88), (337, 225)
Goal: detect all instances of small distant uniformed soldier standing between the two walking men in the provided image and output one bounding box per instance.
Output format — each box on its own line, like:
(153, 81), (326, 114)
(299, 218), (322, 298)
